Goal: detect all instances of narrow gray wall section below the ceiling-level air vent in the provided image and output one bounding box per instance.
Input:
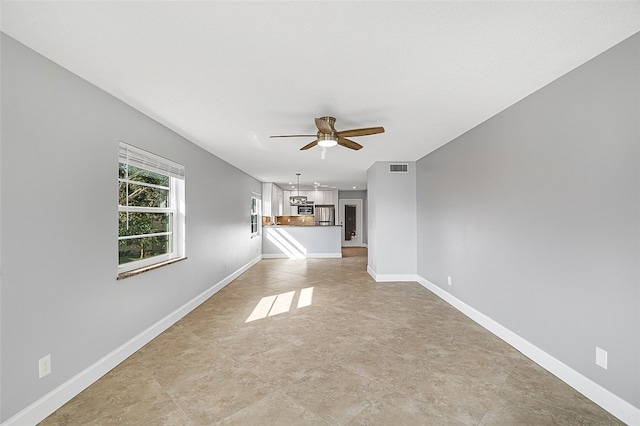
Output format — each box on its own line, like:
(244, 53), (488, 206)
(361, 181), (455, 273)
(367, 161), (417, 279)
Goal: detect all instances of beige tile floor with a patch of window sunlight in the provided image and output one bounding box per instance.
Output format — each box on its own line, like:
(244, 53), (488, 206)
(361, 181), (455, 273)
(41, 251), (621, 426)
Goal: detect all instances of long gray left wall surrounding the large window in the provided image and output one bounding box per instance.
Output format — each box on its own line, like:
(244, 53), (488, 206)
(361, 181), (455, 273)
(0, 34), (261, 421)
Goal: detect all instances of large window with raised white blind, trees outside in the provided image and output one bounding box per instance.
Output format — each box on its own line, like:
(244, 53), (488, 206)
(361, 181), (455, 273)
(118, 142), (184, 272)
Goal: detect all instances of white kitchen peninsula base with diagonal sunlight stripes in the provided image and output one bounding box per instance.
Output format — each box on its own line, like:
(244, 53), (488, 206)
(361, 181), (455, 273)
(262, 225), (342, 259)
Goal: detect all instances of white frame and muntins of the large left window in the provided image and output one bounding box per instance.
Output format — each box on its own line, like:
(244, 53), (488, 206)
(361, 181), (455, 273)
(118, 141), (185, 274)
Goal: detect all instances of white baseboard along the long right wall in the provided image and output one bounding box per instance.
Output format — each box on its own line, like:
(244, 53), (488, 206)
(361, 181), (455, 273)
(416, 274), (640, 426)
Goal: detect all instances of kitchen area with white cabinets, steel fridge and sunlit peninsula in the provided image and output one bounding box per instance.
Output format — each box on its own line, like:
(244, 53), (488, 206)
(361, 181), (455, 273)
(262, 183), (342, 259)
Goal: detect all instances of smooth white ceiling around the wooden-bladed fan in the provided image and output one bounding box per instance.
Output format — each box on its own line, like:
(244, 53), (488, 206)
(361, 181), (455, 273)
(0, 1), (640, 189)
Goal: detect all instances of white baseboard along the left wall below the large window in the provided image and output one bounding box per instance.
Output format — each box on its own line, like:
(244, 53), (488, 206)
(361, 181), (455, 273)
(1, 256), (261, 426)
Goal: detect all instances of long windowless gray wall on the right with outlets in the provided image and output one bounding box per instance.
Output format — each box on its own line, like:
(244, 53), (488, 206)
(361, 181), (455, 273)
(417, 34), (640, 407)
